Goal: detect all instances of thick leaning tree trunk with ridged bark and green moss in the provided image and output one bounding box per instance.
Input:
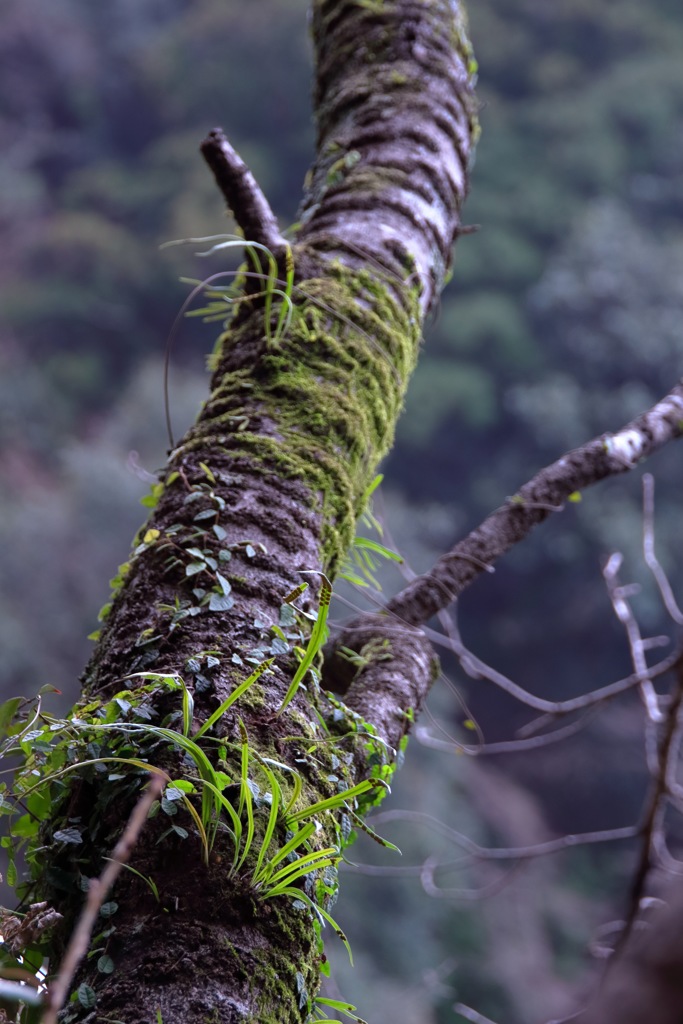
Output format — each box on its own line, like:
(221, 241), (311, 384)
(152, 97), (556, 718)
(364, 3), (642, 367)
(37, 0), (476, 1024)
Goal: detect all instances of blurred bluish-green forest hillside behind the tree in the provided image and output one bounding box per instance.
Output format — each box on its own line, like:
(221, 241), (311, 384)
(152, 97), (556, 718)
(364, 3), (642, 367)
(0, 0), (683, 1024)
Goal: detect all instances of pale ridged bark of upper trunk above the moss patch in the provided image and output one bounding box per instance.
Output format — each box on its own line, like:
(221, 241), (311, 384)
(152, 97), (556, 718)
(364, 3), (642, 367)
(301, 0), (477, 312)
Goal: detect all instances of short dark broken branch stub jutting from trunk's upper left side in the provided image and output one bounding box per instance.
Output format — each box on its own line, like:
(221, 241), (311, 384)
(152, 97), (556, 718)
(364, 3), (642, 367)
(200, 128), (287, 257)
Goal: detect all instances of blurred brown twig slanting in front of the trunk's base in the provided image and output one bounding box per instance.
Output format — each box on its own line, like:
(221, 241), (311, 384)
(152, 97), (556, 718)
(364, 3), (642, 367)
(42, 775), (165, 1024)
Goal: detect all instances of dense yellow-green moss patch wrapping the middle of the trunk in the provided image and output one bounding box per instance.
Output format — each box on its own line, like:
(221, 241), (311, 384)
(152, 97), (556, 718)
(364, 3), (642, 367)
(172, 252), (420, 573)
